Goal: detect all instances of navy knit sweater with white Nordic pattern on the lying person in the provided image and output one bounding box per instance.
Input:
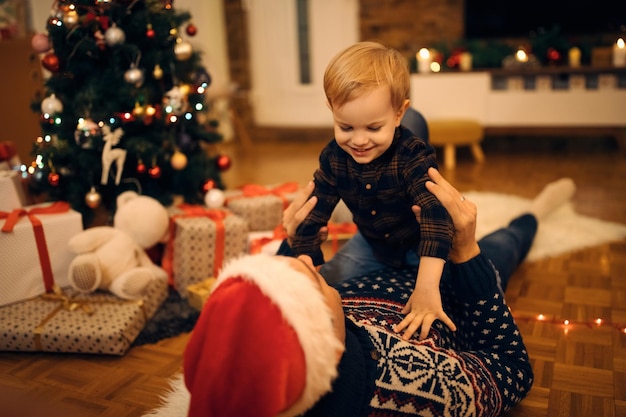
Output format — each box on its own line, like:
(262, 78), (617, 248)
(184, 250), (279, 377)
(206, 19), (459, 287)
(306, 255), (533, 417)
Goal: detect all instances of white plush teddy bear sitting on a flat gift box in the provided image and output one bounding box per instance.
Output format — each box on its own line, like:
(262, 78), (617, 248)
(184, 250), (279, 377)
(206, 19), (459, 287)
(69, 191), (169, 300)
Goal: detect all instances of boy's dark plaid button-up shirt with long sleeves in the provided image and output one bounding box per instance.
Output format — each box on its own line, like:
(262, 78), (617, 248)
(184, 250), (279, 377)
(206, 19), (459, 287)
(292, 126), (453, 266)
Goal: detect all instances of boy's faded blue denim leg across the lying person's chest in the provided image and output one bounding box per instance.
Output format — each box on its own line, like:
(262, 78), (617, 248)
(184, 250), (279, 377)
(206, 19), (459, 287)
(320, 232), (385, 285)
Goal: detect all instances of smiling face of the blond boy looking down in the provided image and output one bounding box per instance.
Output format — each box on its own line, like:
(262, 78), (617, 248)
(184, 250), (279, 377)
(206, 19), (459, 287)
(332, 86), (409, 164)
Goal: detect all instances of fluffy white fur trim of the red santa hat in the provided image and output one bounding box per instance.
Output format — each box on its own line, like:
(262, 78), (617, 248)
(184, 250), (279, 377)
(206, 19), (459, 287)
(213, 254), (344, 417)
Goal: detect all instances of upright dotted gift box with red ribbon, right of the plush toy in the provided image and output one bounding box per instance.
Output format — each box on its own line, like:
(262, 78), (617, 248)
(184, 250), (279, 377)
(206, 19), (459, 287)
(162, 204), (248, 298)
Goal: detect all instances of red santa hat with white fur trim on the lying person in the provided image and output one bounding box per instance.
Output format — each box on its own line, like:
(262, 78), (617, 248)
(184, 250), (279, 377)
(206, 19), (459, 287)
(183, 254), (343, 417)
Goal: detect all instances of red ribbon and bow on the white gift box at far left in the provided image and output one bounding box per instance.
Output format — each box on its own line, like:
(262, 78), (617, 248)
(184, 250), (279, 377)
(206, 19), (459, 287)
(0, 201), (70, 292)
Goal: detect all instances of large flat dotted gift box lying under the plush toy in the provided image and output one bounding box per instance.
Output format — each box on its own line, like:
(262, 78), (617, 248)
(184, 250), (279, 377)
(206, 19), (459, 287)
(0, 278), (168, 355)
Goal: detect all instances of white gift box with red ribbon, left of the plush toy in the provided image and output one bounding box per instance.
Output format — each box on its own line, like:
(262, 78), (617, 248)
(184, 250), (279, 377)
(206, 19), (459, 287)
(0, 202), (83, 306)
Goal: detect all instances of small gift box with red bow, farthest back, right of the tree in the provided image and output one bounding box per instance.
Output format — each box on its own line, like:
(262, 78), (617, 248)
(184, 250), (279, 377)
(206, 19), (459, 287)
(226, 182), (298, 232)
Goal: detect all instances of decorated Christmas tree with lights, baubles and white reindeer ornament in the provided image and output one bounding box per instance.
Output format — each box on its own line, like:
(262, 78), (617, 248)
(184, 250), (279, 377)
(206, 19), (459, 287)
(28, 0), (230, 225)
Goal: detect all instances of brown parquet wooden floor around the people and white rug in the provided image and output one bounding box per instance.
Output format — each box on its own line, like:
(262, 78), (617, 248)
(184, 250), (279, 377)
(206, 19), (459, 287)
(0, 130), (626, 417)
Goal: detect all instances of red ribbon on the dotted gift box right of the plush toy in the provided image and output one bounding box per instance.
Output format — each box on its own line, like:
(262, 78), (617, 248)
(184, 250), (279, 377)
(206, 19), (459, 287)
(161, 204), (230, 287)
